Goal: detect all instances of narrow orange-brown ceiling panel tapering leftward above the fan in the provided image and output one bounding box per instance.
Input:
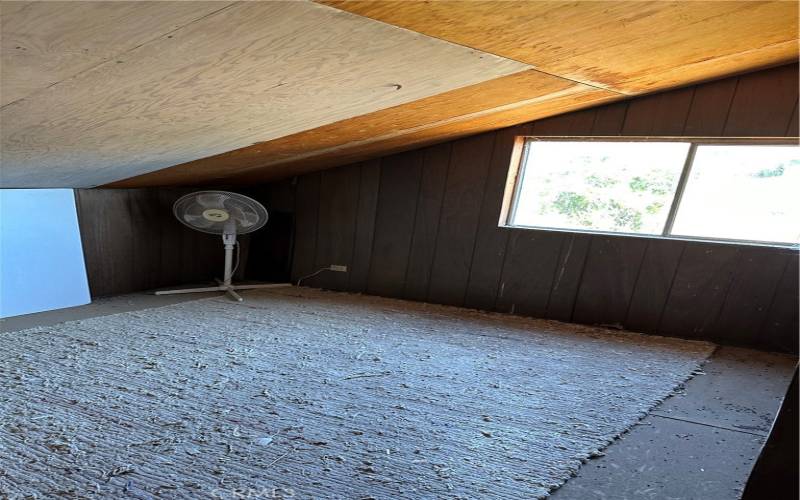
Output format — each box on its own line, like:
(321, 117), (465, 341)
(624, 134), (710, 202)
(106, 70), (623, 187)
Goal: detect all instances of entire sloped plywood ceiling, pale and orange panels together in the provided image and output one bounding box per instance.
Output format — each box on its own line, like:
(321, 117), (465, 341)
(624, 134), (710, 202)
(0, 1), (797, 187)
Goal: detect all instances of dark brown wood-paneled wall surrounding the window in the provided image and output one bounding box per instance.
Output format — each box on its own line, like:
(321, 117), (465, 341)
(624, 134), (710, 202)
(280, 65), (797, 350)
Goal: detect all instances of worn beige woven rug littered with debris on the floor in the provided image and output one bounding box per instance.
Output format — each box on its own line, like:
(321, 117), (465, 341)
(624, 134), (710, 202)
(0, 288), (712, 499)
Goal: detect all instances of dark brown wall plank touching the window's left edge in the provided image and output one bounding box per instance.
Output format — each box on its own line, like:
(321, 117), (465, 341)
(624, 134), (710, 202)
(464, 125), (530, 310)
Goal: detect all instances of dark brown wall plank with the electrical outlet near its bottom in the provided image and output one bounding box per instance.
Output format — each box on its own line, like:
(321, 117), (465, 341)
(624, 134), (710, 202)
(314, 164), (361, 290)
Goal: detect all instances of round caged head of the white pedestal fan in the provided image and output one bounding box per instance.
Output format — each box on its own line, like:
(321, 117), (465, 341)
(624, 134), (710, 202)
(172, 191), (269, 234)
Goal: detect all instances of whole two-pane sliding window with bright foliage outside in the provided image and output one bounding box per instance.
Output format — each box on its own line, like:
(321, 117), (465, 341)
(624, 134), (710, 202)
(501, 138), (800, 244)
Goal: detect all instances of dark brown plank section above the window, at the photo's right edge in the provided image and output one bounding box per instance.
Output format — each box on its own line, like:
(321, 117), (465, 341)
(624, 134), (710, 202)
(724, 64), (798, 137)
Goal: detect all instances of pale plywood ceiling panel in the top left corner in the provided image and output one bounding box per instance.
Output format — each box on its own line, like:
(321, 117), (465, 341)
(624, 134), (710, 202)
(0, 2), (229, 106)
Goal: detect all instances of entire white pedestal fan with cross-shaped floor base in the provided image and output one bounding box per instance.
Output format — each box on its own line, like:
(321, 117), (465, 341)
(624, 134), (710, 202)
(156, 191), (291, 301)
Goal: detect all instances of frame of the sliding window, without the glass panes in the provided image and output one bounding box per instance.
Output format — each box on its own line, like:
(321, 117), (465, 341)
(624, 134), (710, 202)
(498, 136), (800, 249)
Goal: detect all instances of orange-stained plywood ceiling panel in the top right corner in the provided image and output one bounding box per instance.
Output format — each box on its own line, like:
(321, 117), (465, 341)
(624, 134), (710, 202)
(322, 0), (798, 94)
